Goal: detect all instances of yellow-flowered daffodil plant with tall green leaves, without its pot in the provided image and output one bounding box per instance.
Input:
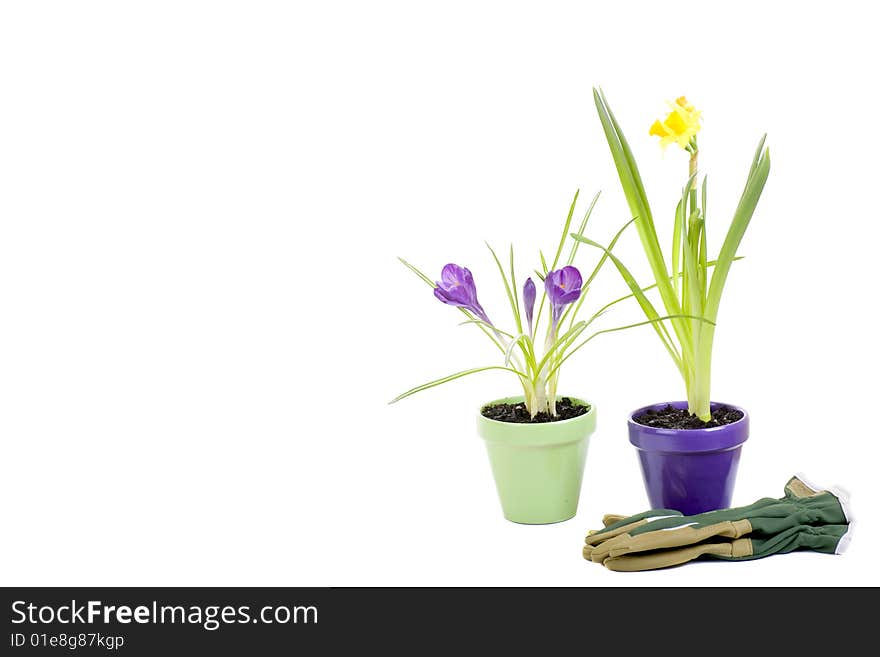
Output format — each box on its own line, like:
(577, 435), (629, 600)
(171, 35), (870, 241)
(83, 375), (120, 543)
(592, 89), (770, 420)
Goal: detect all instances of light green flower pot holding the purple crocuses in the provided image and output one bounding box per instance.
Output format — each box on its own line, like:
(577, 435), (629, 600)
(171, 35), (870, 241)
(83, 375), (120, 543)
(477, 396), (596, 525)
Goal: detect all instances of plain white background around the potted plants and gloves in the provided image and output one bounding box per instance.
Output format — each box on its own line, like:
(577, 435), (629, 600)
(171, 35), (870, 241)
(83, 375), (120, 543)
(0, 1), (880, 586)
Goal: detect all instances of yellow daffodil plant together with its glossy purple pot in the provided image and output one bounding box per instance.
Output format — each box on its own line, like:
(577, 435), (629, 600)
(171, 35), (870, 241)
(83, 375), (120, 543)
(574, 89), (770, 515)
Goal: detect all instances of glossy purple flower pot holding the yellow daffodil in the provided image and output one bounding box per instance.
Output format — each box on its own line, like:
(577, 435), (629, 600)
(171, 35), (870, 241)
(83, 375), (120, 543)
(628, 402), (749, 515)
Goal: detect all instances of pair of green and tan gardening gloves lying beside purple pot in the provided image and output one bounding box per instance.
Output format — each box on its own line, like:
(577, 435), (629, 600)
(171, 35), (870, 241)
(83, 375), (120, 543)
(583, 477), (851, 570)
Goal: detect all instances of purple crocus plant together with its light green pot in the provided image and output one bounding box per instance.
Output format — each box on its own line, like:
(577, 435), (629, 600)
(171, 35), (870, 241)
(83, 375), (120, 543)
(392, 194), (696, 524)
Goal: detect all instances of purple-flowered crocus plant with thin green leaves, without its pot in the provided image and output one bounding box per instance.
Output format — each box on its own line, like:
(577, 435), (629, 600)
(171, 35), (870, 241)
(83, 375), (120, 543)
(391, 192), (702, 418)
